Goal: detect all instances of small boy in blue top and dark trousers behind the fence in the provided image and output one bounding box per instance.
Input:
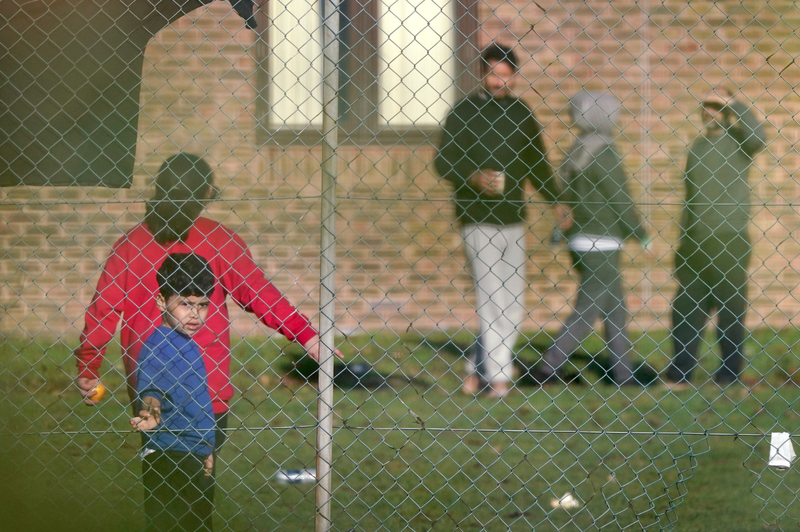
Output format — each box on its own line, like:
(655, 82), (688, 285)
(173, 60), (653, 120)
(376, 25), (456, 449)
(131, 253), (215, 532)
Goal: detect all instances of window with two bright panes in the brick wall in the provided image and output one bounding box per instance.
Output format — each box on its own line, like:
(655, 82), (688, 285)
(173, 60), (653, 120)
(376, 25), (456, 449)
(259, 0), (477, 143)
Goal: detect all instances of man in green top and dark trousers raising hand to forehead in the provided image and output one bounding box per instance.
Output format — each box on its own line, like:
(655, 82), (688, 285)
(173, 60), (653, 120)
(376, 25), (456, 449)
(667, 87), (766, 388)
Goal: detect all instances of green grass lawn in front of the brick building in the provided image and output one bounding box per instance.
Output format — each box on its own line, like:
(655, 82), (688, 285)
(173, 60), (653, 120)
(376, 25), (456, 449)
(0, 329), (800, 531)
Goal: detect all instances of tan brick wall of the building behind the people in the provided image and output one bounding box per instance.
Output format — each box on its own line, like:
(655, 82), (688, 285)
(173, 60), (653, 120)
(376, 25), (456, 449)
(0, 0), (800, 337)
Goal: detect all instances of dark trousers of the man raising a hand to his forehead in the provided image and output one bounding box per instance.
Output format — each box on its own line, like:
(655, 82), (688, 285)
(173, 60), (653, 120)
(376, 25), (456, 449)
(667, 235), (751, 382)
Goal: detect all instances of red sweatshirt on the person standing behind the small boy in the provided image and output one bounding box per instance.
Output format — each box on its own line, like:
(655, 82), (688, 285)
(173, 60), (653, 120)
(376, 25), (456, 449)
(75, 218), (317, 413)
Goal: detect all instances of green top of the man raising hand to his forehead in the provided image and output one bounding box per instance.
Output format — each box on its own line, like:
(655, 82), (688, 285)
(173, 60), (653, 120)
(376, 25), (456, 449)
(681, 100), (766, 245)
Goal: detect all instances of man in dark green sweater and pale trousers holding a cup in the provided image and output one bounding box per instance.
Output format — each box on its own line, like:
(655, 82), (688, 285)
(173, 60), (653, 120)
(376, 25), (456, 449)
(435, 44), (559, 396)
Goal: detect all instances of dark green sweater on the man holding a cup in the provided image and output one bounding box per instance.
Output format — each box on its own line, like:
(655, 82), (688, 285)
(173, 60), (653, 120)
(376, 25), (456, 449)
(434, 92), (559, 226)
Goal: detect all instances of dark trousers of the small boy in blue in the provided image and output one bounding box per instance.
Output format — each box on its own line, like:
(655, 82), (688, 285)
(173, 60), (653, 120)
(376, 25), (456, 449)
(142, 451), (214, 532)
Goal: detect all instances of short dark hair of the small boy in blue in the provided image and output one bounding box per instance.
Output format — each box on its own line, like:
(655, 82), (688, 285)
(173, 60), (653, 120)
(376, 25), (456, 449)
(156, 253), (216, 299)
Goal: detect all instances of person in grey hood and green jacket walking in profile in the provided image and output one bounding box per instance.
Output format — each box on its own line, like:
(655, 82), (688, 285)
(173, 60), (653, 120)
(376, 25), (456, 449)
(534, 91), (648, 385)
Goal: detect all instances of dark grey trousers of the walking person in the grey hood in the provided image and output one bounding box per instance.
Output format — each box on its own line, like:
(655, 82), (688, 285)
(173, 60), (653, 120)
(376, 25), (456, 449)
(542, 251), (632, 384)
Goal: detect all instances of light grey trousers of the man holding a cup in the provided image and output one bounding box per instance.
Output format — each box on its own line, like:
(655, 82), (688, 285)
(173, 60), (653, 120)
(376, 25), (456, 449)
(463, 224), (528, 383)
